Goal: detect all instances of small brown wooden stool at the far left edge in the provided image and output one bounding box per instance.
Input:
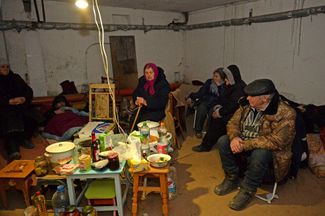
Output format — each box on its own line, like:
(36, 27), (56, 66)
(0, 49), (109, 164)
(0, 160), (34, 208)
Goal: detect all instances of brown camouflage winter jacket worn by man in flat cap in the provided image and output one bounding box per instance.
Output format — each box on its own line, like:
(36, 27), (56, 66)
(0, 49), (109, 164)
(227, 93), (296, 182)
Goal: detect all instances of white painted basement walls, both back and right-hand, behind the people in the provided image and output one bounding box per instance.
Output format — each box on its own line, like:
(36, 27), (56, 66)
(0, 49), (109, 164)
(0, 0), (325, 104)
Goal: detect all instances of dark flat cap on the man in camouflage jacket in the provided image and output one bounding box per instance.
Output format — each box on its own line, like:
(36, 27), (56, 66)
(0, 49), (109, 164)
(244, 79), (276, 96)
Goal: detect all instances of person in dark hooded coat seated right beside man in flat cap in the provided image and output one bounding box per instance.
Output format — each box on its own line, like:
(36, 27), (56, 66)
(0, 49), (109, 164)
(192, 65), (246, 152)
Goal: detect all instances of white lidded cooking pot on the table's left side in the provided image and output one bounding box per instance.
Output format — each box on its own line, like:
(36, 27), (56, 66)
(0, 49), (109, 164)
(45, 142), (75, 167)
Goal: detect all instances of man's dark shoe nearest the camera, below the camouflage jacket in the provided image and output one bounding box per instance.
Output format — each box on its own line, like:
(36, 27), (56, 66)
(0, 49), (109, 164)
(229, 188), (255, 211)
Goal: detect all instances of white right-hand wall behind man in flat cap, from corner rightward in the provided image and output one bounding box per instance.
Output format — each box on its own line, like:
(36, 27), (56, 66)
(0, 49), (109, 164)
(184, 0), (325, 104)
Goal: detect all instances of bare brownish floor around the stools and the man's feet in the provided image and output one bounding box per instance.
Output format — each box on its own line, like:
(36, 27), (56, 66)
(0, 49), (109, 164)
(0, 124), (325, 216)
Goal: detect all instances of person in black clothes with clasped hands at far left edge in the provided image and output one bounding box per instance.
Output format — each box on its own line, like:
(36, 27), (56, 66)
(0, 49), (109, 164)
(0, 58), (42, 161)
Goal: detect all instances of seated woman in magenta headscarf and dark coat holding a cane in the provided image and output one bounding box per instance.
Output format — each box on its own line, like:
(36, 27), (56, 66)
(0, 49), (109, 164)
(133, 63), (170, 125)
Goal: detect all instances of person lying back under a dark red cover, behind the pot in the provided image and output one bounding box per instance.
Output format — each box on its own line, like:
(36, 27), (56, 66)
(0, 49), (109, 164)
(42, 95), (89, 141)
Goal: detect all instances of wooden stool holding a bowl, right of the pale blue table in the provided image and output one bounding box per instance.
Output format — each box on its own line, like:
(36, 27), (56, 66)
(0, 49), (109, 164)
(130, 166), (169, 216)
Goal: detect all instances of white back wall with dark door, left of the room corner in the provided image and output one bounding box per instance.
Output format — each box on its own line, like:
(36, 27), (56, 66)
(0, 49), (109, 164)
(0, 0), (184, 96)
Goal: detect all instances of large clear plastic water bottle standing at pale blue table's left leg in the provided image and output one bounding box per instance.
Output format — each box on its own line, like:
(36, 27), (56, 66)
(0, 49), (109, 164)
(52, 185), (69, 216)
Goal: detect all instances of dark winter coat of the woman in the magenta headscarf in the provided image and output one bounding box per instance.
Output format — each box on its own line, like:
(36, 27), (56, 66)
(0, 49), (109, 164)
(133, 70), (170, 121)
